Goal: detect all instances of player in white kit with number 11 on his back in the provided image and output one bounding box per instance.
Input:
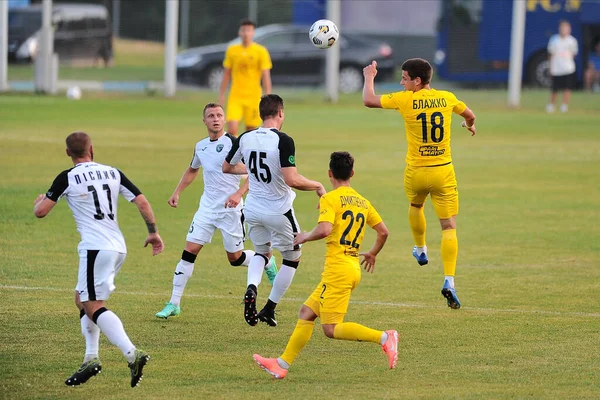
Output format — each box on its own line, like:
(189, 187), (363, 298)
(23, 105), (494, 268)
(33, 132), (164, 387)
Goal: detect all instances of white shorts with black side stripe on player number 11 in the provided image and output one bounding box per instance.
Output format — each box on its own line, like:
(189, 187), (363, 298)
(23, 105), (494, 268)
(75, 250), (127, 302)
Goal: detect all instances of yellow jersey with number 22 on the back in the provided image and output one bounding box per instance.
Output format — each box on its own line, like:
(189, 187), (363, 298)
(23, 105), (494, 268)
(319, 186), (382, 274)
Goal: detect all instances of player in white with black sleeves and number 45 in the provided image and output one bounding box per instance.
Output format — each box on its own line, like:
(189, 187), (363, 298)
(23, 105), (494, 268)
(223, 94), (325, 326)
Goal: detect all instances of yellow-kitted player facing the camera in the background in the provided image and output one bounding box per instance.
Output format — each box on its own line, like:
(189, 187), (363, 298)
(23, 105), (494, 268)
(219, 19), (273, 136)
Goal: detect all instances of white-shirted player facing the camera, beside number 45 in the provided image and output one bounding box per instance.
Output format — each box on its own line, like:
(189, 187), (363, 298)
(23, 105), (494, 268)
(156, 103), (277, 319)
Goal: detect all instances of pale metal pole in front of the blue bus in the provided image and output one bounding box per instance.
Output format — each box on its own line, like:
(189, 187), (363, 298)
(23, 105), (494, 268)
(508, 0), (527, 107)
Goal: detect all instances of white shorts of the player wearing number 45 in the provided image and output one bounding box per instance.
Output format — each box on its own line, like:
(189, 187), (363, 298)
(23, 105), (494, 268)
(244, 208), (300, 251)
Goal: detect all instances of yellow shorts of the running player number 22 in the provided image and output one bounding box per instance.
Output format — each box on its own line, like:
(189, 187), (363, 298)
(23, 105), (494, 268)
(304, 267), (360, 324)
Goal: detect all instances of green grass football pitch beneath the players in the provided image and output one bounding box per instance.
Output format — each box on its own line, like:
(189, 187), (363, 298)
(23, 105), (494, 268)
(0, 90), (600, 399)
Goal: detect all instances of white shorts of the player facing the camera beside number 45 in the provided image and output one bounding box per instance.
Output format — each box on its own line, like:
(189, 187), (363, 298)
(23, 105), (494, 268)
(185, 209), (246, 253)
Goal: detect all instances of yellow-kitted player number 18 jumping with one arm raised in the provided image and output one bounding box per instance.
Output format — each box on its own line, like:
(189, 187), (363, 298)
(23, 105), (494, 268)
(363, 58), (475, 309)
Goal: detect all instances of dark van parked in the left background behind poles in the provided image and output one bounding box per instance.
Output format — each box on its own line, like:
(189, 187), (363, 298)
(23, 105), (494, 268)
(7, 0), (113, 64)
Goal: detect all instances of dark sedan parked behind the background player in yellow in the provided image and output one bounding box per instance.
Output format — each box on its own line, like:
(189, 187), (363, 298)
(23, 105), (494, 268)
(177, 24), (394, 93)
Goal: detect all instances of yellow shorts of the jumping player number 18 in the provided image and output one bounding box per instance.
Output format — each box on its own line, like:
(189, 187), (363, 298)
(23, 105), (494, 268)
(404, 164), (458, 219)
